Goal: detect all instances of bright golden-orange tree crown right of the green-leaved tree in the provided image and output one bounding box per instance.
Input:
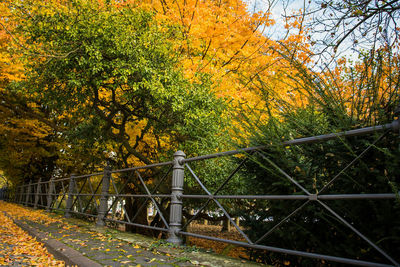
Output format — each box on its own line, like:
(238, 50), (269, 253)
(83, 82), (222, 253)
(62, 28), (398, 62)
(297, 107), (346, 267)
(114, 0), (308, 143)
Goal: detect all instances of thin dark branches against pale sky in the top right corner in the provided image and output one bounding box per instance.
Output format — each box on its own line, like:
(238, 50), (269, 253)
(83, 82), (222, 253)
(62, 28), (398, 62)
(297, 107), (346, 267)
(309, 0), (400, 52)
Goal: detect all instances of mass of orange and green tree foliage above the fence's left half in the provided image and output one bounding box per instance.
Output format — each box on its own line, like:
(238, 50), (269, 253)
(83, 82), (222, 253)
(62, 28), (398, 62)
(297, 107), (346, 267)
(0, 0), (304, 186)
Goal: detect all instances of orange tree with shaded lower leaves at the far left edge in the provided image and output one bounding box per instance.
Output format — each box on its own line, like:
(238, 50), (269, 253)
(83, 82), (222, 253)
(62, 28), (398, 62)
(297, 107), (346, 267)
(0, 2), (61, 186)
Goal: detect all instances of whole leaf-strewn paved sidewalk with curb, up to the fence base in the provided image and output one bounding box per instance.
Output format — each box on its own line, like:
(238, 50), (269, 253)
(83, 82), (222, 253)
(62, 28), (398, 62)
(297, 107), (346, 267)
(0, 203), (259, 267)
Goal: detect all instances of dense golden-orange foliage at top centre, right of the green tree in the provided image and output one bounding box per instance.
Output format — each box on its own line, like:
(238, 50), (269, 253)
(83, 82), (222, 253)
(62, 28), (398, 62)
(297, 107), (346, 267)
(126, 0), (280, 102)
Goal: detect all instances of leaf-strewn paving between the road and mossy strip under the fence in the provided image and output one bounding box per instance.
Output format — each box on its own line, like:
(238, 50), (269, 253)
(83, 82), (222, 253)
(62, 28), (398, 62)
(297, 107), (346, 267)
(0, 202), (204, 267)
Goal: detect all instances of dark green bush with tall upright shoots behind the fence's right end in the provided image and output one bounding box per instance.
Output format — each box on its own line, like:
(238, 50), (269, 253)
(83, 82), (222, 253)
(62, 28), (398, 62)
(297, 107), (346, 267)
(241, 49), (400, 266)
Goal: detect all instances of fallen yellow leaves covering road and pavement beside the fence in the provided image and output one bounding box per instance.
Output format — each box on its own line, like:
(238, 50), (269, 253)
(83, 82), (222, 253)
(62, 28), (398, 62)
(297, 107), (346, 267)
(0, 202), (205, 267)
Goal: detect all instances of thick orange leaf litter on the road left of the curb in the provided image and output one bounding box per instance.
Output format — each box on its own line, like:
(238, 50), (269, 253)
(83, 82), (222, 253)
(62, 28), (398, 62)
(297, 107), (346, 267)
(0, 201), (64, 266)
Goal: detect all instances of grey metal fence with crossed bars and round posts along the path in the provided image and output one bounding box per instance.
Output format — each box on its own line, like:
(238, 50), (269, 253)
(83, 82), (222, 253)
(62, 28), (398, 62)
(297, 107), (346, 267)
(9, 120), (400, 266)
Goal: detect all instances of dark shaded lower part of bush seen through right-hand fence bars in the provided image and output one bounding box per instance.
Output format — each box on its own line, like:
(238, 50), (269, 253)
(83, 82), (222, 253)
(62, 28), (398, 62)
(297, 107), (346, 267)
(239, 112), (400, 264)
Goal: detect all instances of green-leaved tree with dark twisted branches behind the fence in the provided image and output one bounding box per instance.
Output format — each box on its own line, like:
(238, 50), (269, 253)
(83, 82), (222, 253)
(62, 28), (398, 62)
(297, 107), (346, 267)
(9, 0), (225, 174)
